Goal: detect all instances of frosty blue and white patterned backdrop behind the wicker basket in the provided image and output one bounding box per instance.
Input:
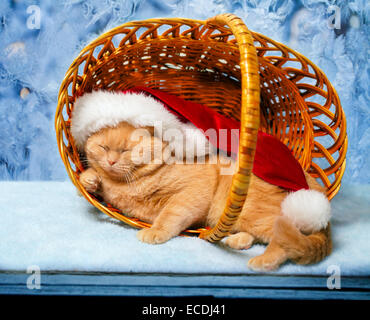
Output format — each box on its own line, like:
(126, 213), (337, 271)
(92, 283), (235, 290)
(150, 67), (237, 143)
(0, 0), (370, 183)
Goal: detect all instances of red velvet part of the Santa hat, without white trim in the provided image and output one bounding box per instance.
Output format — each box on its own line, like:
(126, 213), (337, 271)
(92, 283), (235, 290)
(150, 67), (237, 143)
(123, 87), (308, 191)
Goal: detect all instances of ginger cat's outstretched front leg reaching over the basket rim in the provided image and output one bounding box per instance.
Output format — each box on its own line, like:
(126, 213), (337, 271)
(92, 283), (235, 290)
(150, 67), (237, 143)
(137, 206), (204, 244)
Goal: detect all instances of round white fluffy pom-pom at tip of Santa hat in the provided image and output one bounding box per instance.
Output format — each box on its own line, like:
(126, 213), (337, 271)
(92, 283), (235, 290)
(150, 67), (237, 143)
(281, 189), (331, 233)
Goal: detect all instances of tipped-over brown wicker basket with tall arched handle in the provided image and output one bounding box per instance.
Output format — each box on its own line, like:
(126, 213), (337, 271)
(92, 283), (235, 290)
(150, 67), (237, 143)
(55, 14), (347, 241)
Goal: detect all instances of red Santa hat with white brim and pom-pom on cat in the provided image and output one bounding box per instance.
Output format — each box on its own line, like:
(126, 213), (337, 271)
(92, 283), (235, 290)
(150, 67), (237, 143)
(71, 87), (330, 231)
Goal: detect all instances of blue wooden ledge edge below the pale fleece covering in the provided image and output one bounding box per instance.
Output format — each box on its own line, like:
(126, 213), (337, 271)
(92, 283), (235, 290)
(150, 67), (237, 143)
(0, 272), (370, 300)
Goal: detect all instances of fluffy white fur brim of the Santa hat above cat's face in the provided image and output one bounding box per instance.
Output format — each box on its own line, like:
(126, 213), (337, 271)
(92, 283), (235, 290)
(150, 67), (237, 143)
(71, 91), (215, 156)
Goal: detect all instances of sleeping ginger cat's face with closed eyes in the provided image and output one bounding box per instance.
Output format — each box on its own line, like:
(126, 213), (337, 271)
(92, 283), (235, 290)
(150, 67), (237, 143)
(85, 123), (163, 180)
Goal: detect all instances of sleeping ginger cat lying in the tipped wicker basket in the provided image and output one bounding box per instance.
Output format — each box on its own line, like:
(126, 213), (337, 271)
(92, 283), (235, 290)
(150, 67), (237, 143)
(80, 122), (331, 271)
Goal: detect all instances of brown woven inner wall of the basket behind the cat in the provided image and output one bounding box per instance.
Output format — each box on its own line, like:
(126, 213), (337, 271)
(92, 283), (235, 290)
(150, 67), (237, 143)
(79, 39), (313, 169)
